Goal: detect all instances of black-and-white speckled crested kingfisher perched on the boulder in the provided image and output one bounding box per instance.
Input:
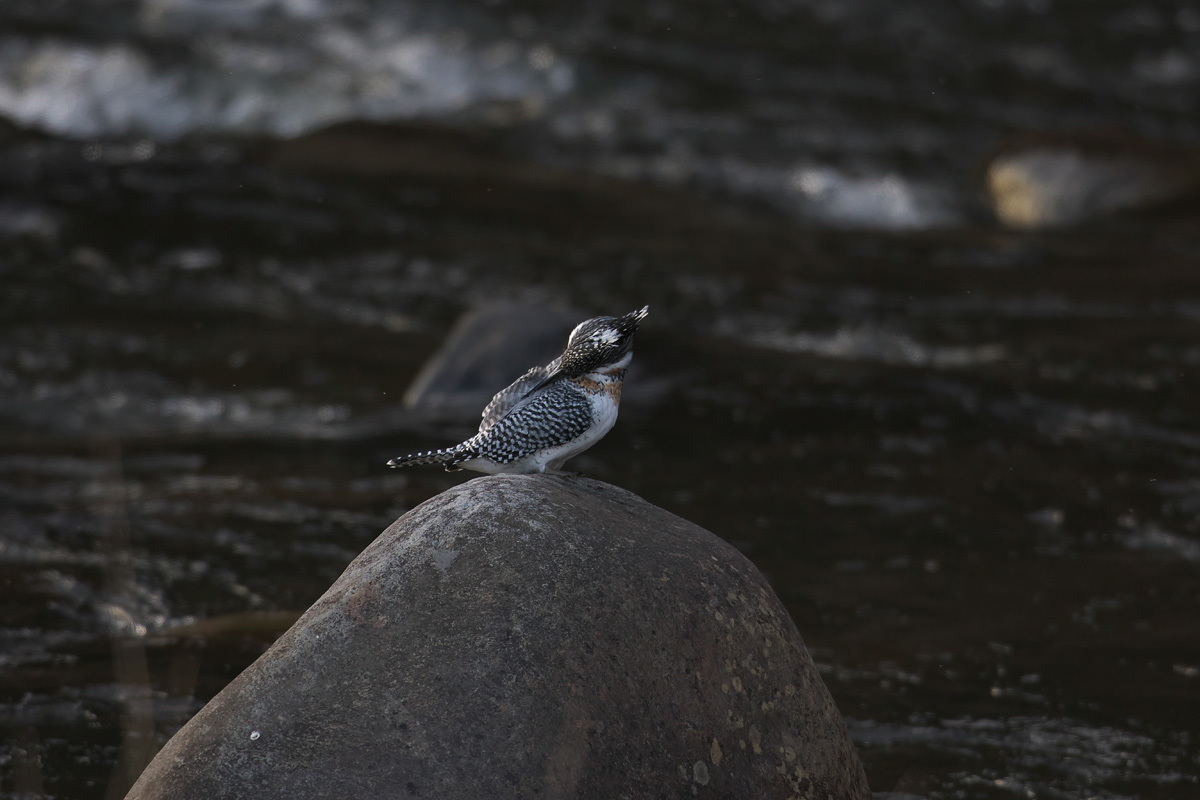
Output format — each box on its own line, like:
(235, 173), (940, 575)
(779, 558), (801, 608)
(388, 306), (650, 475)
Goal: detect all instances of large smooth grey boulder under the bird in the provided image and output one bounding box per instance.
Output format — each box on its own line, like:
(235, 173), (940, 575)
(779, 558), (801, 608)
(128, 475), (870, 800)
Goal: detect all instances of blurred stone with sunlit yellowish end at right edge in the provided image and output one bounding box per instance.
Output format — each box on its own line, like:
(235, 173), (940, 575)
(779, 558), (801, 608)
(986, 139), (1200, 229)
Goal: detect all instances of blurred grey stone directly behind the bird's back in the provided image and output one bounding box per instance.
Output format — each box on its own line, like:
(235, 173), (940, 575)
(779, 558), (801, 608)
(404, 305), (588, 411)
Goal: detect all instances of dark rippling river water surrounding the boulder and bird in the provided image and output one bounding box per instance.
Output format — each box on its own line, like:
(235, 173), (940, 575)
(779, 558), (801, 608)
(0, 0), (1200, 799)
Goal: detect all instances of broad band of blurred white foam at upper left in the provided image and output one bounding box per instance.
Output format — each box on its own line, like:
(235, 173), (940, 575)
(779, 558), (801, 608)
(0, 2), (574, 139)
